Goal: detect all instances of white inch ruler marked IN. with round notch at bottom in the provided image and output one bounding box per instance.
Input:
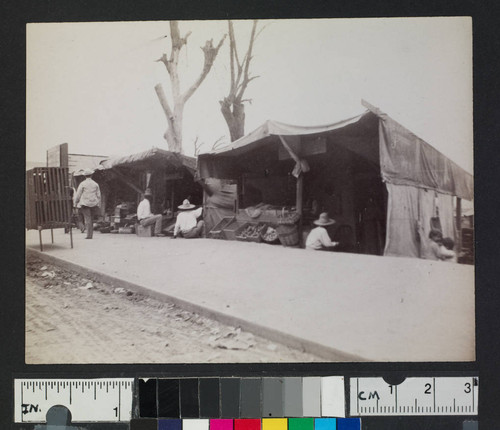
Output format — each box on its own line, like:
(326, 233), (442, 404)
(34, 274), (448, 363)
(14, 378), (134, 423)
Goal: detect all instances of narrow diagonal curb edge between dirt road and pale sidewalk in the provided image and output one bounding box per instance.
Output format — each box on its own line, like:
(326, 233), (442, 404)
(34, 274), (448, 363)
(26, 248), (371, 362)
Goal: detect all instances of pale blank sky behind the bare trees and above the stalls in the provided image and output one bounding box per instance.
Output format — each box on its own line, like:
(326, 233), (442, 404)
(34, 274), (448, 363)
(26, 17), (473, 173)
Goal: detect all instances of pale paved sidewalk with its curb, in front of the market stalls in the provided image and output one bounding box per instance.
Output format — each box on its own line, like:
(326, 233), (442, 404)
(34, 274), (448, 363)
(26, 229), (475, 361)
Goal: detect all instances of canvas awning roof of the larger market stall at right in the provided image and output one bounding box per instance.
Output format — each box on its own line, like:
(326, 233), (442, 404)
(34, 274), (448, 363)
(198, 102), (474, 200)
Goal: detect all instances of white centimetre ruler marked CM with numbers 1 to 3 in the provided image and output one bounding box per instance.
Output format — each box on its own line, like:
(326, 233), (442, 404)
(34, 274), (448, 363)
(350, 376), (479, 416)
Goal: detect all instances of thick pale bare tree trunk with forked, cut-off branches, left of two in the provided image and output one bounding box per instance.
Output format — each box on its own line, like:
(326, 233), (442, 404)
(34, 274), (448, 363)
(155, 21), (226, 152)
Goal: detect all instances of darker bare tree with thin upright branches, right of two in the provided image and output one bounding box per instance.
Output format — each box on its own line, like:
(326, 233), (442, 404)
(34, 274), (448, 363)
(219, 20), (263, 142)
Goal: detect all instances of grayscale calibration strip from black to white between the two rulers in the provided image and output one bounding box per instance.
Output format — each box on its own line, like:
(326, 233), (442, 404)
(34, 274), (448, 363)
(138, 376), (345, 418)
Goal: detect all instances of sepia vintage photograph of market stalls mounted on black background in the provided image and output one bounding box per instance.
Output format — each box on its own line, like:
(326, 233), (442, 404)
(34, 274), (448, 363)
(25, 17), (476, 364)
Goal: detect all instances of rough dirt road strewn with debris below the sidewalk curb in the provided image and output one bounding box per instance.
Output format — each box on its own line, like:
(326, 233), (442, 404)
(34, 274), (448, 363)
(26, 257), (324, 364)
